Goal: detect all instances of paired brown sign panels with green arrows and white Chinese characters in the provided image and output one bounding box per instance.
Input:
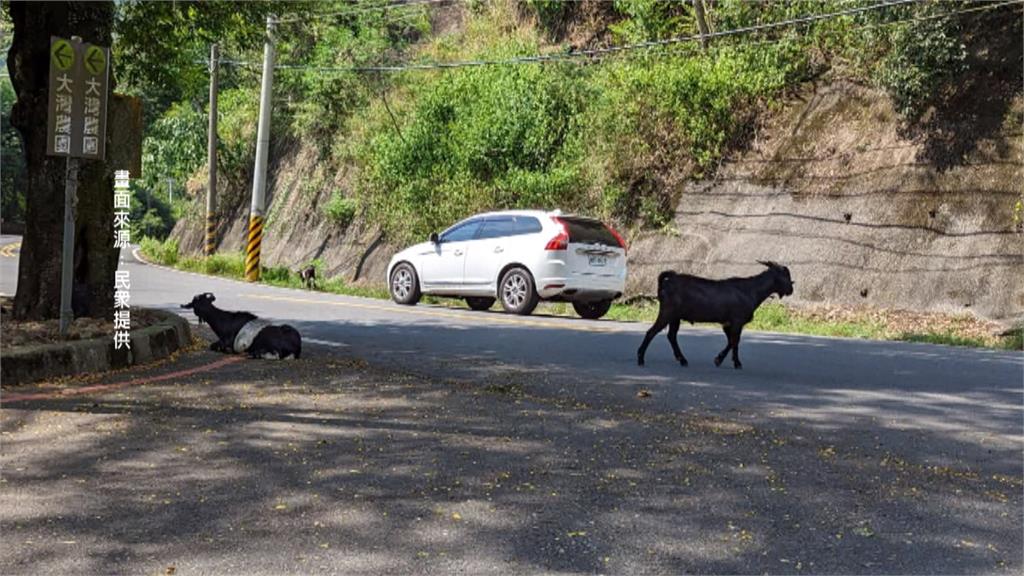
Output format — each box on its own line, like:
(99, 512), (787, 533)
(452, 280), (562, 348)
(46, 36), (111, 160)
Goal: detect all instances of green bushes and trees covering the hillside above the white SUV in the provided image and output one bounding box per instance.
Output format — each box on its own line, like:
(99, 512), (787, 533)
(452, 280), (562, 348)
(96, 0), (991, 243)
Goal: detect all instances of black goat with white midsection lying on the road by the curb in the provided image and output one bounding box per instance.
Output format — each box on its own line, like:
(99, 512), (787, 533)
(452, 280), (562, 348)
(181, 292), (302, 360)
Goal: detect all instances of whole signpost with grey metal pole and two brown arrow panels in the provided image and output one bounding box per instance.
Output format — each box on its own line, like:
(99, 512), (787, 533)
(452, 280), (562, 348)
(46, 36), (111, 336)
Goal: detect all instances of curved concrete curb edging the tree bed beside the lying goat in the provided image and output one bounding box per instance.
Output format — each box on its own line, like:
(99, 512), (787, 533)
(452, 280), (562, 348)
(0, 311), (191, 387)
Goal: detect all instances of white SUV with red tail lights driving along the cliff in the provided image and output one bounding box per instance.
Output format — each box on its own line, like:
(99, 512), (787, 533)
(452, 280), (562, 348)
(387, 210), (626, 319)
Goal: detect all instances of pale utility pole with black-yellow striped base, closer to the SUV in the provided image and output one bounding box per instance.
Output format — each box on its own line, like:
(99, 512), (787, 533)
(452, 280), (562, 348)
(246, 14), (275, 282)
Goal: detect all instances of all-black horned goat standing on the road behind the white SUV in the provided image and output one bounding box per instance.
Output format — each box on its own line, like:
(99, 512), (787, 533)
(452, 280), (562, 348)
(637, 260), (794, 368)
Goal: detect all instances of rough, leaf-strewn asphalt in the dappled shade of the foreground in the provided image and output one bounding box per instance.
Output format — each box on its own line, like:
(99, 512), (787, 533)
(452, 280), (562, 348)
(0, 334), (1022, 574)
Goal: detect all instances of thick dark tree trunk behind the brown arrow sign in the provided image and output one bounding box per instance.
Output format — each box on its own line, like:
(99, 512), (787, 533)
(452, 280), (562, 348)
(7, 2), (118, 320)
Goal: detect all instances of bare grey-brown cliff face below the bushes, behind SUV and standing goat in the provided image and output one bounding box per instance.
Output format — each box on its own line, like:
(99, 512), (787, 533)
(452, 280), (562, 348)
(173, 84), (1024, 319)
